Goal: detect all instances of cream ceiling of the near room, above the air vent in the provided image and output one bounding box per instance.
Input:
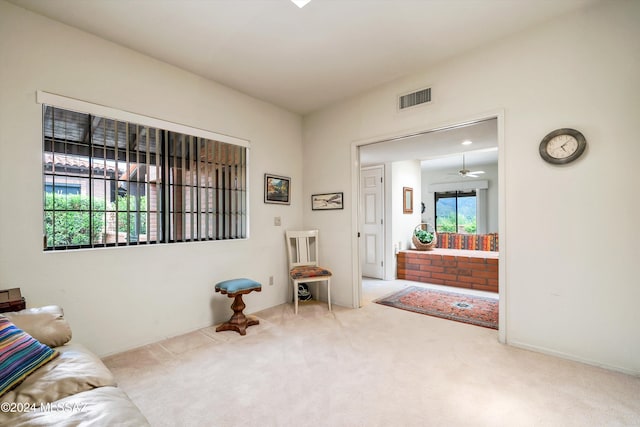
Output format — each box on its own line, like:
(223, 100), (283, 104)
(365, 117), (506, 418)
(9, 0), (597, 114)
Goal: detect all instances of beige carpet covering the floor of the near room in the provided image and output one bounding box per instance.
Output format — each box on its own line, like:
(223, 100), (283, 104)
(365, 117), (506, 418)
(105, 281), (640, 427)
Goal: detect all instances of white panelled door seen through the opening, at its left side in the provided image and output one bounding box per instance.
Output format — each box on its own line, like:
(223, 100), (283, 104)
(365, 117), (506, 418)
(360, 166), (384, 279)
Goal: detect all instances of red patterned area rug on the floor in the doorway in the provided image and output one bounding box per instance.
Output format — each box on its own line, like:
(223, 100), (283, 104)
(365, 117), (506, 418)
(374, 286), (498, 329)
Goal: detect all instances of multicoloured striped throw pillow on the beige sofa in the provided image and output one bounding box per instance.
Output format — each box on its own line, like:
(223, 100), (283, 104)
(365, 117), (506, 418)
(0, 316), (59, 396)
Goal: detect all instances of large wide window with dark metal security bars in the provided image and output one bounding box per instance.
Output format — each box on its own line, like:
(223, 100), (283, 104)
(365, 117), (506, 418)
(43, 104), (247, 250)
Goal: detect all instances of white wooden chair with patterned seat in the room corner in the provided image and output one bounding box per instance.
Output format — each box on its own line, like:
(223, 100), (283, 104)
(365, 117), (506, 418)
(285, 230), (331, 314)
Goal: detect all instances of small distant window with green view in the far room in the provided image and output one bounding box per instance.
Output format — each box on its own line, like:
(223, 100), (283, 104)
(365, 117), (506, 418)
(435, 190), (476, 233)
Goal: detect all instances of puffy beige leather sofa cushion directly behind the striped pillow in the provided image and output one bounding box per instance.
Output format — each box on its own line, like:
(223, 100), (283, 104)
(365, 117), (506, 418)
(4, 305), (71, 347)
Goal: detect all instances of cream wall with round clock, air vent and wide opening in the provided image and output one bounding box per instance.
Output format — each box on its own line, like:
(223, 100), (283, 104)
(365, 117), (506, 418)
(303, 1), (640, 374)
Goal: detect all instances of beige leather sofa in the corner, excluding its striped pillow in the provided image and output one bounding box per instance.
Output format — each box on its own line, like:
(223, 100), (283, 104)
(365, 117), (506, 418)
(0, 306), (149, 427)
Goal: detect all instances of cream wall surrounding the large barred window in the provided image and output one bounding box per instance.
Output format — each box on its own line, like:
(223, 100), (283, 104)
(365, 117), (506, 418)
(0, 0), (304, 355)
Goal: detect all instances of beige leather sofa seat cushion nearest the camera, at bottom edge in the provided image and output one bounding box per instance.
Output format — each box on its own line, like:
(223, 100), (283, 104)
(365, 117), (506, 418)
(4, 387), (150, 427)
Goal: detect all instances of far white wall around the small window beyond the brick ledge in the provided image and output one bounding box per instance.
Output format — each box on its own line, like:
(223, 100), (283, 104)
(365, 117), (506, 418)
(422, 164), (498, 233)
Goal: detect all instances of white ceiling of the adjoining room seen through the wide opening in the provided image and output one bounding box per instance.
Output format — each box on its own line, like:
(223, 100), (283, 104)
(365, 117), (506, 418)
(360, 119), (498, 170)
